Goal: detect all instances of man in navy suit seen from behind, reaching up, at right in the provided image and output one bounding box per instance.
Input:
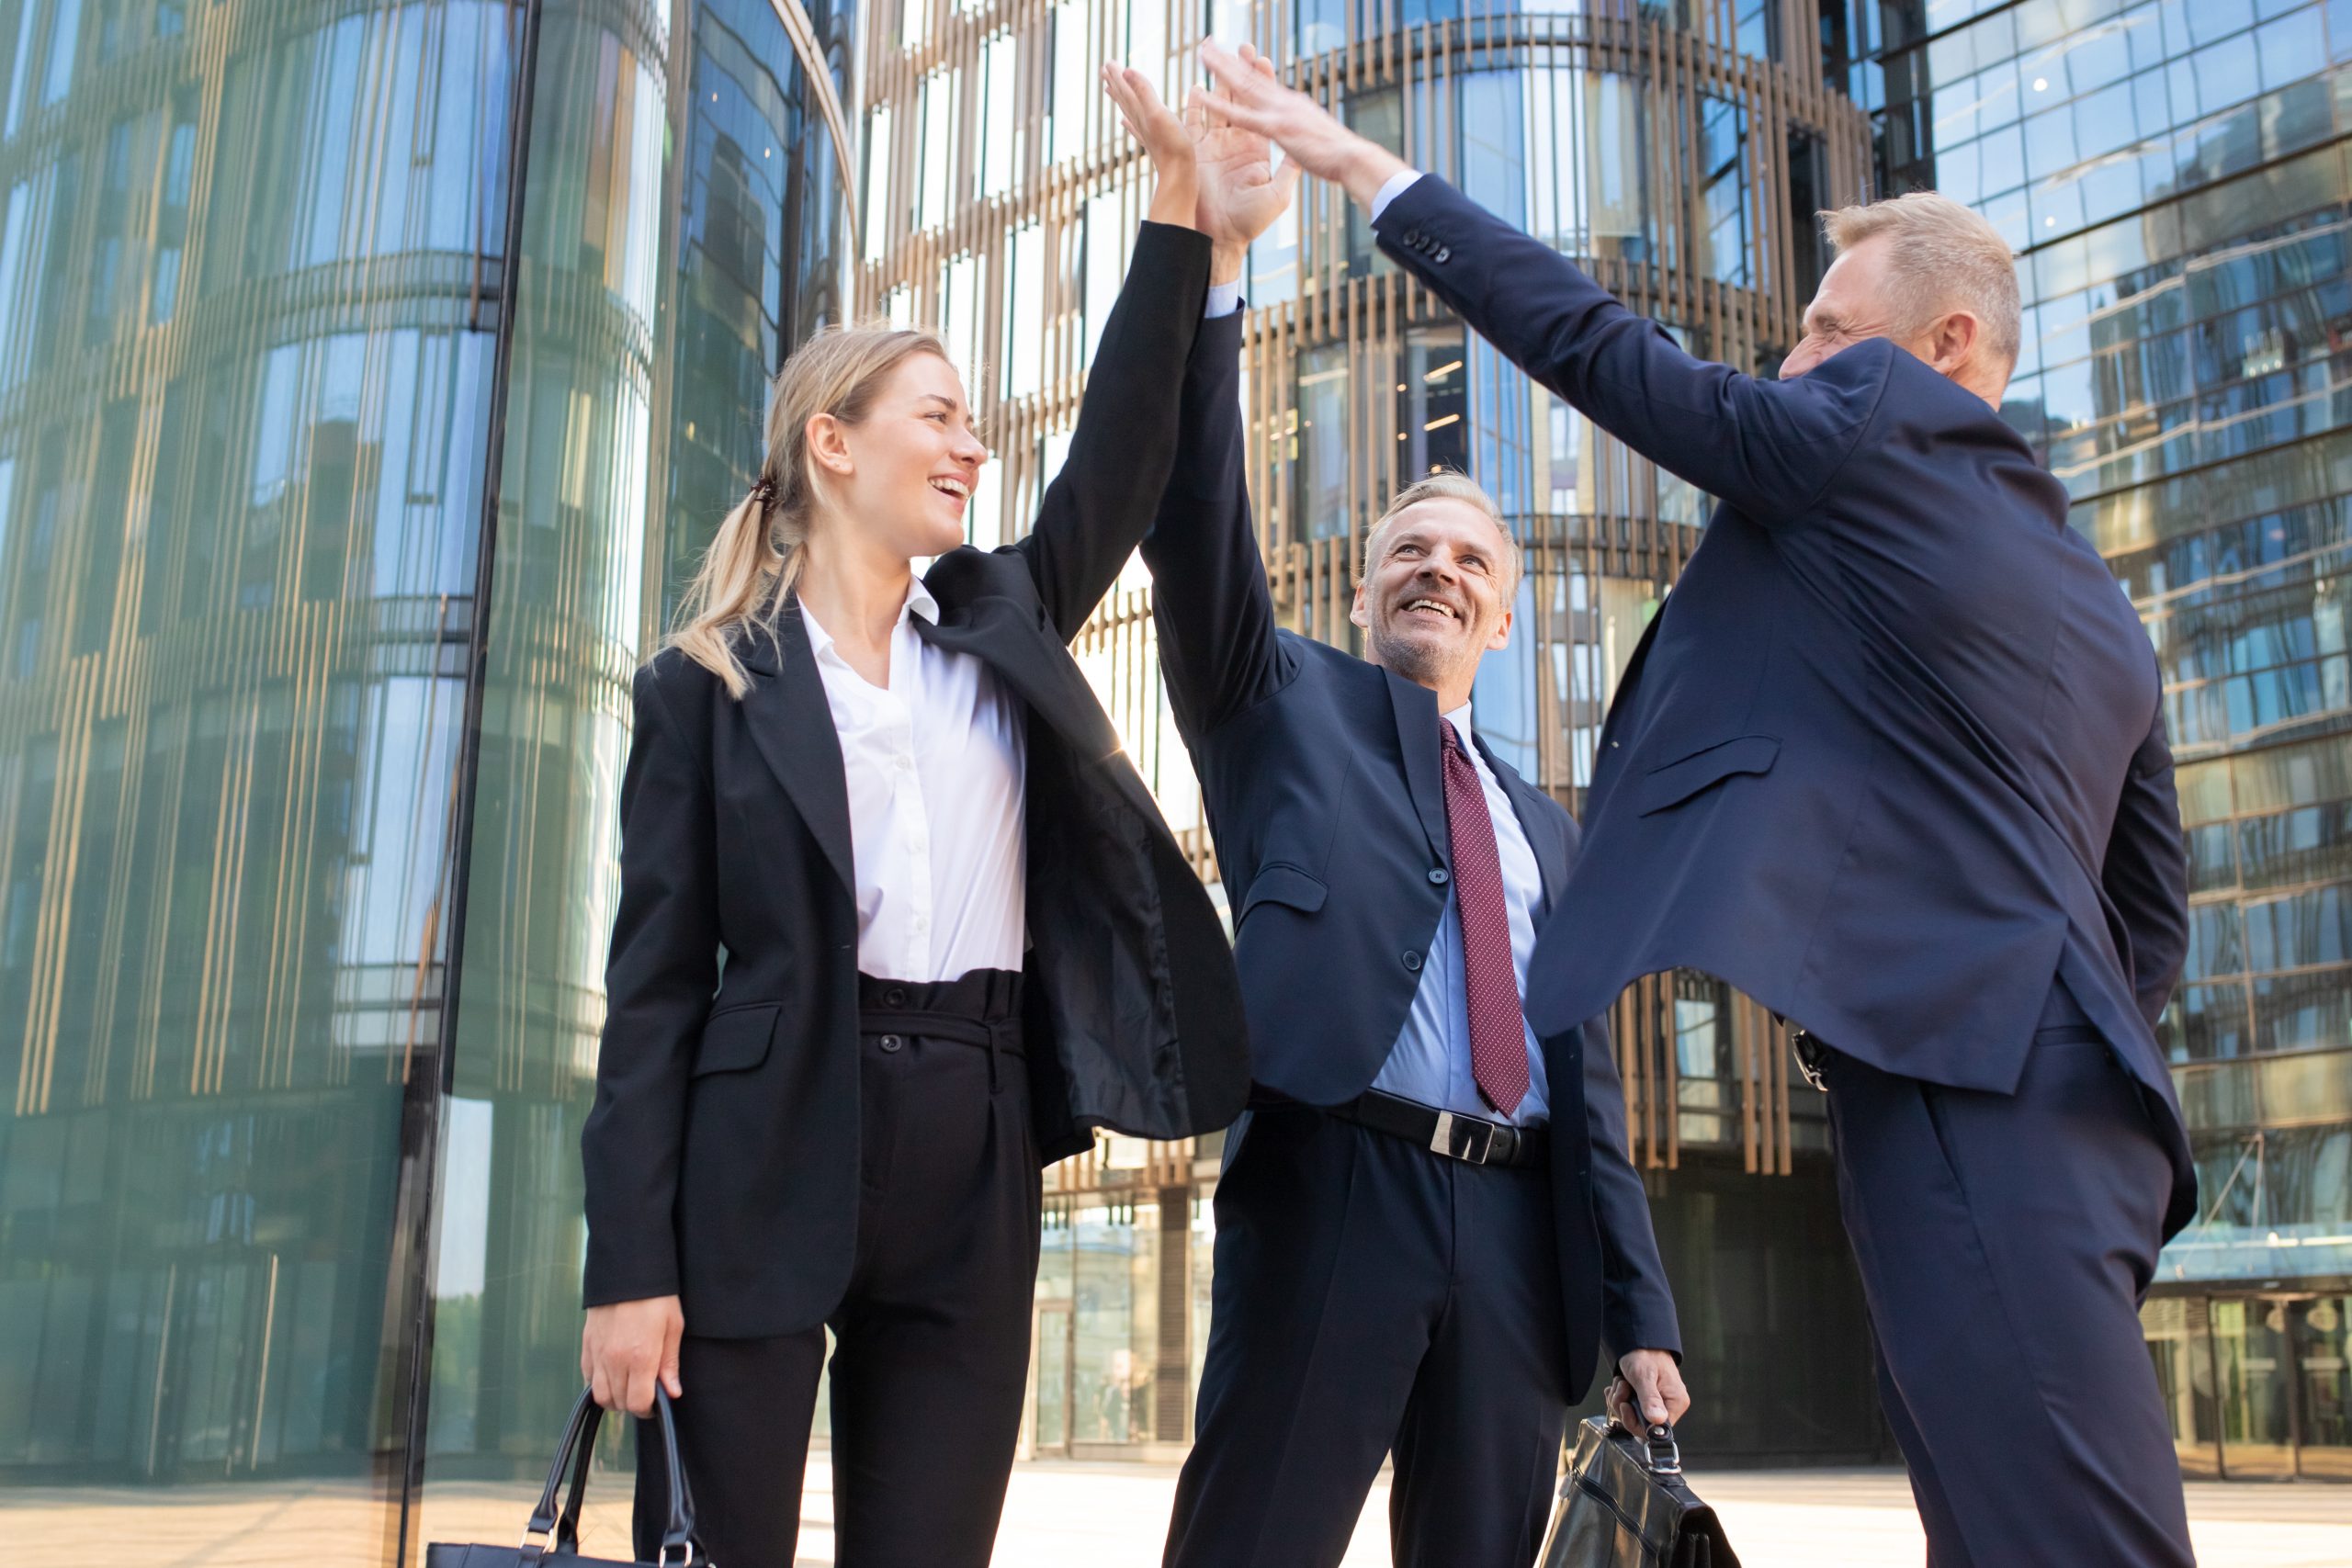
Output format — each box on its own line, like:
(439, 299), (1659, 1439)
(1179, 45), (2197, 1568)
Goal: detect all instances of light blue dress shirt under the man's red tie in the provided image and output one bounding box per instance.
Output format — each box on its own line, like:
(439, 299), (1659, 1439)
(1371, 703), (1553, 1126)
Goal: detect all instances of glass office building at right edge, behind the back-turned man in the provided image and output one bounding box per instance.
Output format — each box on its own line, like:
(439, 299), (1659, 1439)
(1851, 0), (2352, 1479)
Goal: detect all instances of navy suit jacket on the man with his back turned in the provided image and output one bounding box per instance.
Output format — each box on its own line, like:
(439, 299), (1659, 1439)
(1376, 176), (2194, 1232)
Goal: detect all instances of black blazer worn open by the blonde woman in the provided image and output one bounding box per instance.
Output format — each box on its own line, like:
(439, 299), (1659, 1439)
(581, 223), (1249, 1337)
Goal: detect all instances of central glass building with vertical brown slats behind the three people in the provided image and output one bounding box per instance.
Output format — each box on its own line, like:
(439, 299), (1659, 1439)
(856, 0), (1891, 1460)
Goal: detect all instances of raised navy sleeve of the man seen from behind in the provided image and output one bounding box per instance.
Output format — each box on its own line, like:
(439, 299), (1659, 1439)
(1374, 174), (1894, 525)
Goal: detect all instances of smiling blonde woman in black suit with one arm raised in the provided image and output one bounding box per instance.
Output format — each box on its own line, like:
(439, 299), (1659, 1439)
(581, 73), (1249, 1568)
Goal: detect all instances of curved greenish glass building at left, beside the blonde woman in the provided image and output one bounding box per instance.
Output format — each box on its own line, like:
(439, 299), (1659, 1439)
(0, 0), (854, 1563)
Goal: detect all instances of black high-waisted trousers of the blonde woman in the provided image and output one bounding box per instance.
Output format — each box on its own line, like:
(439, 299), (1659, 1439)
(638, 971), (1040, 1568)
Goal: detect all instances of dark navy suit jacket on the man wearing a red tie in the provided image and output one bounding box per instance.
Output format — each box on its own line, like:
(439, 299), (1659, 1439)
(1143, 315), (1681, 1389)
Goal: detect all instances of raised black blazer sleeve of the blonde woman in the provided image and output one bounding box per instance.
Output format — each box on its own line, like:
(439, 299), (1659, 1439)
(1009, 223), (1209, 642)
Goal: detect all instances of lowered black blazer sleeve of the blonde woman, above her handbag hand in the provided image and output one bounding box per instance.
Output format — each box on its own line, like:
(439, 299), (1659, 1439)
(581, 653), (719, 1307)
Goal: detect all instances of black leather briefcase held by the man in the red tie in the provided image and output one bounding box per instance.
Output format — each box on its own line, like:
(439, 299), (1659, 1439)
(1536, 1416), (1740, 1568)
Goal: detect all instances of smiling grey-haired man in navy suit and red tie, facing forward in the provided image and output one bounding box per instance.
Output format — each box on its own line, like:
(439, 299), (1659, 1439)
(1143, 76), (1689, 1568)
